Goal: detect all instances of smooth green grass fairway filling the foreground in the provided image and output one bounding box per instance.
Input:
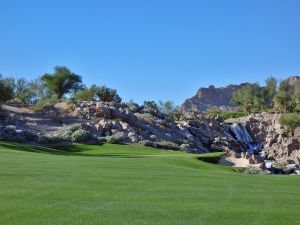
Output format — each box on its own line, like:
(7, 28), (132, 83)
(0, 142), (300, 225)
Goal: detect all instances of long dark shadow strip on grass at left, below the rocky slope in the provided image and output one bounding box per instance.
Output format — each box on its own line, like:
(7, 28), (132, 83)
(0, 142), (143, 158)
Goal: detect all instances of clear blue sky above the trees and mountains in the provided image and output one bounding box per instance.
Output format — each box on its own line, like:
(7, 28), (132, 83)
(0, 0), (300, 104)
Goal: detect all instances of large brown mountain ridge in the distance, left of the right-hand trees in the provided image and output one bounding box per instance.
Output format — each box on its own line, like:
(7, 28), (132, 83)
(181, 83), (248, 112)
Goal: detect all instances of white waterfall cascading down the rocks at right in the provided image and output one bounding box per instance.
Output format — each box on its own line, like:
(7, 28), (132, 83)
(230, 123), (262, 154)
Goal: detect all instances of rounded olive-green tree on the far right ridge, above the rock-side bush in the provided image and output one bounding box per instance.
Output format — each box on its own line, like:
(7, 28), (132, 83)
(274, 80), (297, 112)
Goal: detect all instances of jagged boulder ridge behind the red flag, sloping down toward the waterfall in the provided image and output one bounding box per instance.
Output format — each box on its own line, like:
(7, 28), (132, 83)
(72, 102), (237, 153)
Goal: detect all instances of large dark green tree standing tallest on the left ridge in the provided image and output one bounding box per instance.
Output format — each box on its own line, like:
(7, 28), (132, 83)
(42, 66), (82, 99)
